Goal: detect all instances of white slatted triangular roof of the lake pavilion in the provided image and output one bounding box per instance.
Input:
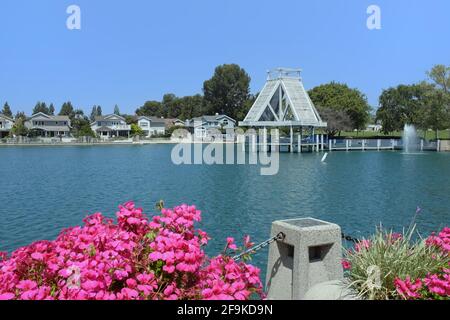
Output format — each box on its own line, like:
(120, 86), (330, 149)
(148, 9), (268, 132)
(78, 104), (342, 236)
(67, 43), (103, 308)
(239, 68), (327, 127)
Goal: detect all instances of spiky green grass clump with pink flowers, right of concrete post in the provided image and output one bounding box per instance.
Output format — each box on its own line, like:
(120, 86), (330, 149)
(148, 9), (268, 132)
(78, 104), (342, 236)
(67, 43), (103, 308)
(342, 228), (450, 299)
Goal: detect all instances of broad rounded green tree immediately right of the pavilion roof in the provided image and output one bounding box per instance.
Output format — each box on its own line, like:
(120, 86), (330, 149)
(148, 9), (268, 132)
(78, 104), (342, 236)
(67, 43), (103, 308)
(308, 82), (370, 130)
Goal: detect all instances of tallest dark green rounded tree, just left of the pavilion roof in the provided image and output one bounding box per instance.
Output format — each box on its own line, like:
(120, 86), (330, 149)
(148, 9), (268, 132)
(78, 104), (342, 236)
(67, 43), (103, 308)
(203, 64), (251, 118)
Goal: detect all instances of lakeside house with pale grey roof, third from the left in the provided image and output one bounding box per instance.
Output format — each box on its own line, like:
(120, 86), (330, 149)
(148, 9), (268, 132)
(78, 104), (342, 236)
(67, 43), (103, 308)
(91, 114), (131, 139)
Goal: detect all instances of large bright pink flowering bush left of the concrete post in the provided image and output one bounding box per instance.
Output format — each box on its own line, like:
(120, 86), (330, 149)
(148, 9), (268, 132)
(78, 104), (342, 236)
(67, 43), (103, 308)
(0, 202), (263, 300)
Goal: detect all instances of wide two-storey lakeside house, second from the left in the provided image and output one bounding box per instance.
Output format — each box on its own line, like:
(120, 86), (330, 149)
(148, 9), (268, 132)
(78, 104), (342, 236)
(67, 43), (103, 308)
(25, 112), (71, 138)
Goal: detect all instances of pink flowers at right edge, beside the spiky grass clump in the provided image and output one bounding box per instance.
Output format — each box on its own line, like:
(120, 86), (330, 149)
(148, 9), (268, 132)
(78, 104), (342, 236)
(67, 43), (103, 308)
(395, 228), (450, 300)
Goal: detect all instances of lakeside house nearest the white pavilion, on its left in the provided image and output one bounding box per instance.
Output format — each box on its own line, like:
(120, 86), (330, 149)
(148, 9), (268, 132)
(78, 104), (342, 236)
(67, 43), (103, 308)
(185, 114), (236, 138)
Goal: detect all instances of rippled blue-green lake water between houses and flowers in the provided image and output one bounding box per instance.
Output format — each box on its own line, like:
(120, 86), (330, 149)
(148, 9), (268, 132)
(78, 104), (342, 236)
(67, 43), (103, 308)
(0, 145), (450, 276)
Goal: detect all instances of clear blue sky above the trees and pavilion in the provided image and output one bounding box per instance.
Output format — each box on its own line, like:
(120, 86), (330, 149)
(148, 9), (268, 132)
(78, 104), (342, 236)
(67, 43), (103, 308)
(0, 0), (450, 113)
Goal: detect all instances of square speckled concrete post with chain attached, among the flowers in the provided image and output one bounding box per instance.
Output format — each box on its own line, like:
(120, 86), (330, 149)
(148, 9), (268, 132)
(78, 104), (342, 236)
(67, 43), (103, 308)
(266, 218), (343, 300)
